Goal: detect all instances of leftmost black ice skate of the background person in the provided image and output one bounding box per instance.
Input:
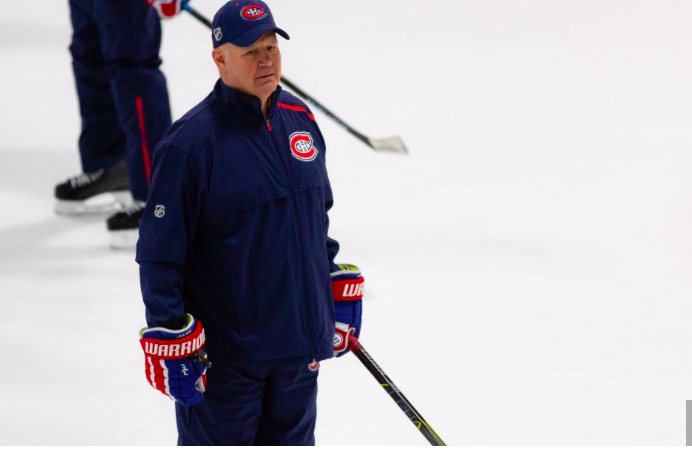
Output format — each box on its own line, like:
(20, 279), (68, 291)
(55, 161), (132, 216)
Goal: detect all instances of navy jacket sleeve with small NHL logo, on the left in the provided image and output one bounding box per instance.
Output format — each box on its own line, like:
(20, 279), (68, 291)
(136, 144), (206, 328)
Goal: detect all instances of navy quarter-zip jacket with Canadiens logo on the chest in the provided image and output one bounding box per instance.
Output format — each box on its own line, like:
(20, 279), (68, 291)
(137, 80), (339, 366)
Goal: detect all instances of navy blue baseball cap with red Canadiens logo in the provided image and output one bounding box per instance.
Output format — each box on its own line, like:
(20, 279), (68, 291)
(211, 0), (290, 48)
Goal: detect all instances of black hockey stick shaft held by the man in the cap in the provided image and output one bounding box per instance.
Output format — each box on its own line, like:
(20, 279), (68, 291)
(348, 335), (447, 446)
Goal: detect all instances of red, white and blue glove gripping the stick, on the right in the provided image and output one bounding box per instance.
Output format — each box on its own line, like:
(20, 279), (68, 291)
(332, 264), (365, 357)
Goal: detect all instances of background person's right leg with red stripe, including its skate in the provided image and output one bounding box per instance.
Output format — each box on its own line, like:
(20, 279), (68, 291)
(95, 0), (171, 247)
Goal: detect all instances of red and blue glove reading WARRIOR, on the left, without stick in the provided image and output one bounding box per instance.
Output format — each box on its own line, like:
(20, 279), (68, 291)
(139, 314), (211, 406)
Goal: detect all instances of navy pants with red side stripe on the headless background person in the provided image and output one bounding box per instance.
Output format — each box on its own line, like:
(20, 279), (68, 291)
(69, 0), (171, 201)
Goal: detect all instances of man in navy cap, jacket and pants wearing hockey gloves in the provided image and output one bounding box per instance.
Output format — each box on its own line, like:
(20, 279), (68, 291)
(132, 0), (363, 445)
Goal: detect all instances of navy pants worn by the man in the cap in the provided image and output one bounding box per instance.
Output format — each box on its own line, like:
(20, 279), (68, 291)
(176, 361), (318, 446)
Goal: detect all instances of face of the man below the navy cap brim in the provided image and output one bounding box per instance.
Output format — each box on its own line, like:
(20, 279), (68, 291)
(214, 31), (281, 102)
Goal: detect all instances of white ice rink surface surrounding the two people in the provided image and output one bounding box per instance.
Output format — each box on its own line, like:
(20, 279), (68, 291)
(0, 0), (692, 445)
